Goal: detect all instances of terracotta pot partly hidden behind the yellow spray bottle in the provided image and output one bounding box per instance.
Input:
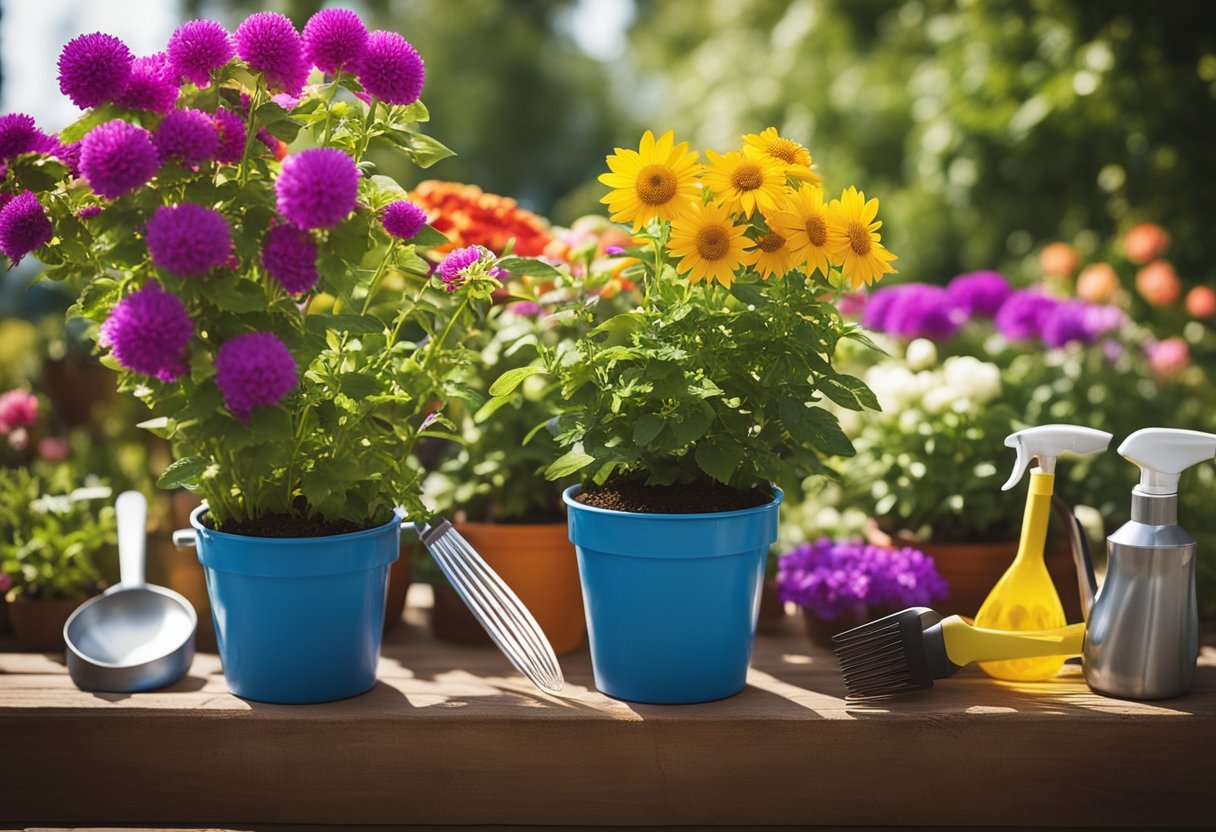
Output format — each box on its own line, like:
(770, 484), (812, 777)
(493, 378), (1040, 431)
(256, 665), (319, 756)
(867, 530), (1081, 622)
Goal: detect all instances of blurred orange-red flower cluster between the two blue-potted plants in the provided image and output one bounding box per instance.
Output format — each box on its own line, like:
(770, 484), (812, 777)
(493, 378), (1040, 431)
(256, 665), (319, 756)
(409, 179), (552, 257)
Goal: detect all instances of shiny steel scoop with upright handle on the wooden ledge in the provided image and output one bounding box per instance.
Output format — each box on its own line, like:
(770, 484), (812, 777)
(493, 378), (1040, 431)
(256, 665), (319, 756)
(63, 491), (198, 693)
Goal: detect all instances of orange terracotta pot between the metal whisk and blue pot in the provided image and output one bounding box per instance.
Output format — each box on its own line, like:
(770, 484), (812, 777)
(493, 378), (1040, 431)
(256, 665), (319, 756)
(456, 522), (586, 656)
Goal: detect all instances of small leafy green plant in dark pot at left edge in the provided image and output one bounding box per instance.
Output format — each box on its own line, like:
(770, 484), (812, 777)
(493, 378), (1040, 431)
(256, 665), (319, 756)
(0, 463), (117, 651)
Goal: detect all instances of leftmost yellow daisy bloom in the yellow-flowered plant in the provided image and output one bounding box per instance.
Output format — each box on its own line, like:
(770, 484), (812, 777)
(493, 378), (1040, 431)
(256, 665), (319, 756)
(599, 130), (700, 231)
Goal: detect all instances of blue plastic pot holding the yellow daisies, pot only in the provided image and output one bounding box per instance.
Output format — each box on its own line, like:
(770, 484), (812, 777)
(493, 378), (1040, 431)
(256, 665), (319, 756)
(562, 487), (783, 704)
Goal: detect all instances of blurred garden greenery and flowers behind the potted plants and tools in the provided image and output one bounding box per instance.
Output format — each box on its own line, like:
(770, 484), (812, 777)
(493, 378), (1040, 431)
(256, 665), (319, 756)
(0, 0), (1216, 617)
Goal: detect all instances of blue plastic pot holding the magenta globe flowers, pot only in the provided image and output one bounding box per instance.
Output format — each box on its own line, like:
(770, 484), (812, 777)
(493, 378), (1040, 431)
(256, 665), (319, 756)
(190, 506), (401, 704)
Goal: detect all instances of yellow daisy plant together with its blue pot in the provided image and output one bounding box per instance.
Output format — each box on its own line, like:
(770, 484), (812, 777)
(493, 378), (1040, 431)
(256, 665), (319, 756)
(492, 130), (894, 703)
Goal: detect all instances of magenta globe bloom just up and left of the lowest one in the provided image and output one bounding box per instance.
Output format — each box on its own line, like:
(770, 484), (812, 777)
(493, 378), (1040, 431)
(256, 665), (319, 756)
(100, 281), (195, 382)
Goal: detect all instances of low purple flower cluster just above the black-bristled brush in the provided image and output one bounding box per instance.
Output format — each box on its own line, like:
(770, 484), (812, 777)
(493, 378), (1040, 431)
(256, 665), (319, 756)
(777, 538), (950, 620)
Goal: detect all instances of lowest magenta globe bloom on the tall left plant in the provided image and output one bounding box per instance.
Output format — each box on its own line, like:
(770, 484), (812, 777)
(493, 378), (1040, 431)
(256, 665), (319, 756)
(215, 332), (295, 422)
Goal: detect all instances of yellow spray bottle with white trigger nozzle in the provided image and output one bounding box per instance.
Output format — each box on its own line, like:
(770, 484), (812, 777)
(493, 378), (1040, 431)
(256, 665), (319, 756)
(975, 425), (1110, 681)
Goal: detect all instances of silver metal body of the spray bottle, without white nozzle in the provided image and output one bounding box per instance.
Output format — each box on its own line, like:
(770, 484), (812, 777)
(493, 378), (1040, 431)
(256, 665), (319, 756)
(1083, 491), (1199, 699)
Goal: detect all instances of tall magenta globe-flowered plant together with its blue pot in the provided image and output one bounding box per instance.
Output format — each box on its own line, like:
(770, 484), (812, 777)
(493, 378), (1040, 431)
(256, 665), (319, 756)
(0, 9), (552, 703)
